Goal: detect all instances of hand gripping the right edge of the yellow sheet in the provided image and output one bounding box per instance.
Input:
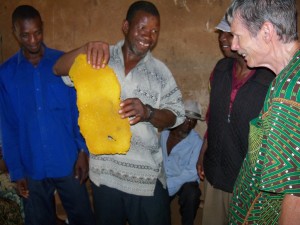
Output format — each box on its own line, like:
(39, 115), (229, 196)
(119, 98), (148, 125)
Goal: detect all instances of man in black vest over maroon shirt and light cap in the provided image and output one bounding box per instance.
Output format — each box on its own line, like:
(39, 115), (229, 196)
(197, 18), (275, 225)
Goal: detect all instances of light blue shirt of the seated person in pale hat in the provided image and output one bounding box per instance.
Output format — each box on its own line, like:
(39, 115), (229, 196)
(160, 130), (202, 196)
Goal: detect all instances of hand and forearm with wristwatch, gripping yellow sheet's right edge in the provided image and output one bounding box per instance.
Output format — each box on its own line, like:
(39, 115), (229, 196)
(119, 98), (176, 129)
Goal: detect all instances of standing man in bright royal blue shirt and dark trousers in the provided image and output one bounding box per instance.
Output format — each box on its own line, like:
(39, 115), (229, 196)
(0, 5), (94, 225)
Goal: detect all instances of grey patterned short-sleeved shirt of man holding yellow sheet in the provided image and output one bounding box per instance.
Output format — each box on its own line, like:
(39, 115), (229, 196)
(89, 41), (184, 196)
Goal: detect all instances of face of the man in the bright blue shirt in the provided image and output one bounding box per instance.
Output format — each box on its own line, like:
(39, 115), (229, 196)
(14, 18), (43, 55)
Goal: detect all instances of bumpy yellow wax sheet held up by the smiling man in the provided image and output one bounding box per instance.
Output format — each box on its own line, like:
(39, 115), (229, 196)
(69, 54), (131, 155)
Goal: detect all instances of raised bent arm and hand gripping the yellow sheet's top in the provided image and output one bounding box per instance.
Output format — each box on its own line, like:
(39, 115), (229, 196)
(53, 41), (110, 76)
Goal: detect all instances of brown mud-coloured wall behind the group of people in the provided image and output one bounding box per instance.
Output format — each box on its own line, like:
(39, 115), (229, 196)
(0, 0), (299, 134)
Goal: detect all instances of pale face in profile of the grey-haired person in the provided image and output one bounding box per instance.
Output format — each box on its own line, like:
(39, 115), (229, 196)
(231, 16), (268, 67)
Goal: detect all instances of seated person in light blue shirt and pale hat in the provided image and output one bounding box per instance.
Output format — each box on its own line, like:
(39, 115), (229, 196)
(160, 100), (202, 225)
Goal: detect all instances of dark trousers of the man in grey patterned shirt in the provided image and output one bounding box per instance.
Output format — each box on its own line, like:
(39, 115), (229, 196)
(92, 181), (171, 225)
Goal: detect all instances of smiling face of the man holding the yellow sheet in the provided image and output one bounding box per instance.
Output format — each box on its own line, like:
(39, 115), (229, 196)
(123, 11), (160, 57)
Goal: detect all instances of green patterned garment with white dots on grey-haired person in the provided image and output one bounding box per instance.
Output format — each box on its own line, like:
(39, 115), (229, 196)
(229, 51), (300, 225)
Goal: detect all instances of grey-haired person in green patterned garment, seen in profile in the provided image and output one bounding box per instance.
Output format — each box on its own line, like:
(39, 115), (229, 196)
(227, 0), (300, 225)
